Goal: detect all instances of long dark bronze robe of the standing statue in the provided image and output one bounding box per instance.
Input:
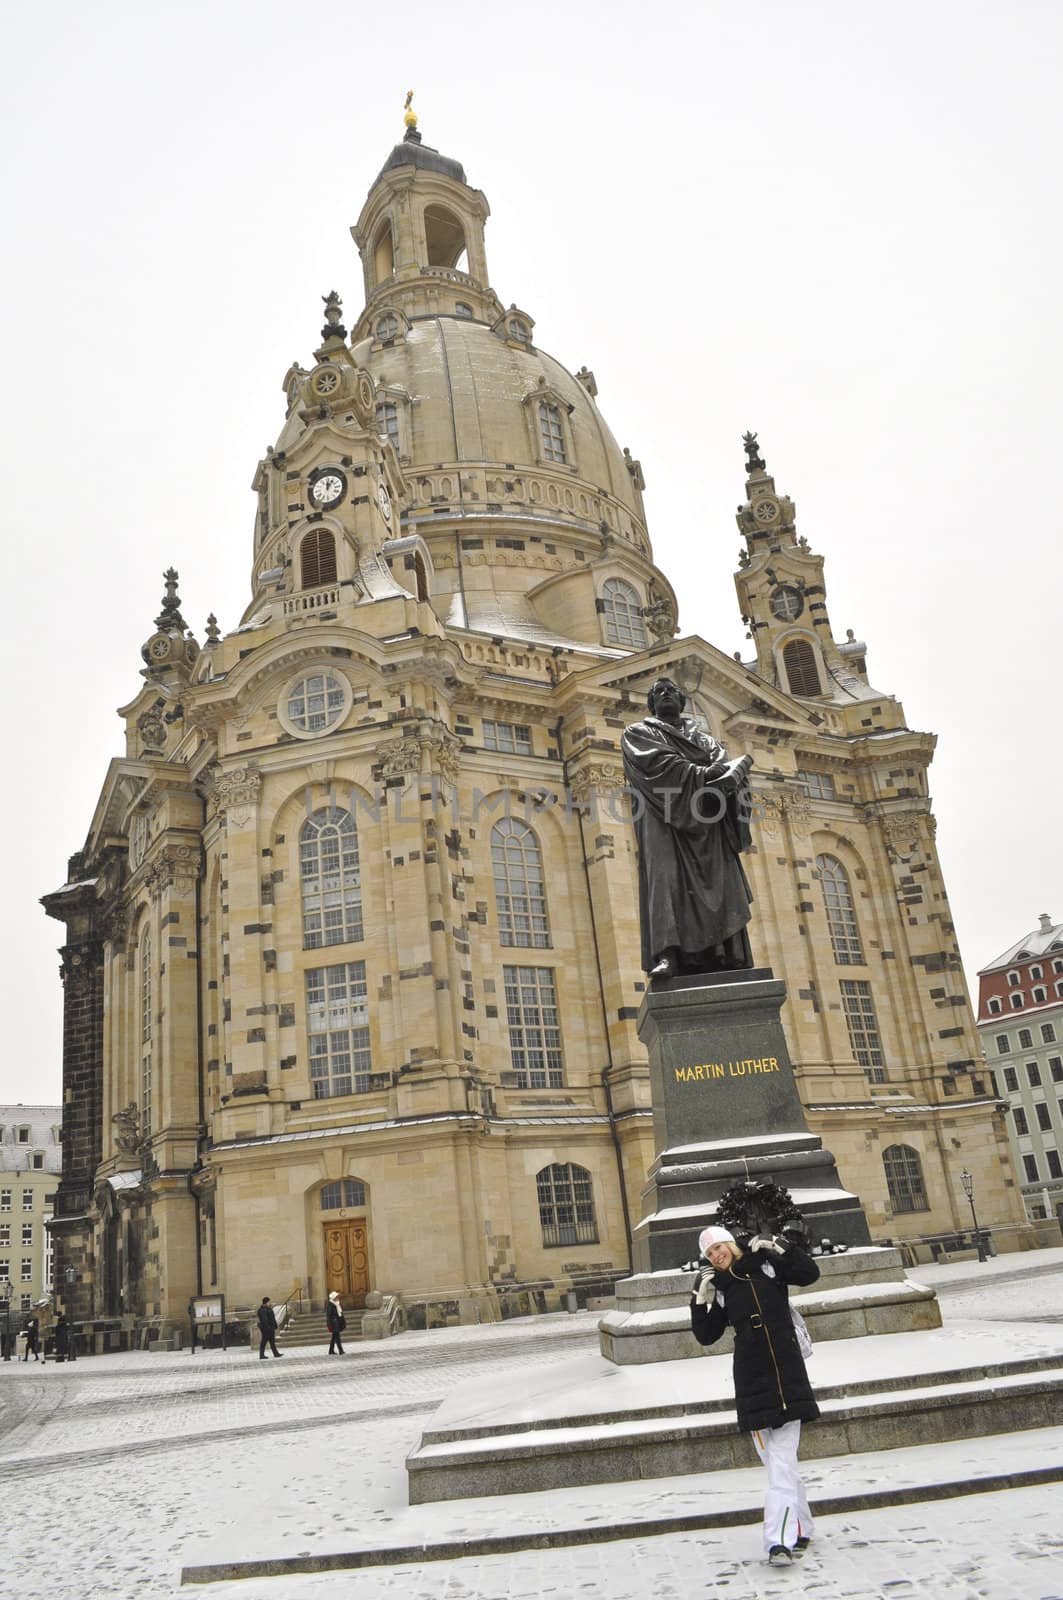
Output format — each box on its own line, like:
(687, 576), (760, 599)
(623, 717), (752, 973)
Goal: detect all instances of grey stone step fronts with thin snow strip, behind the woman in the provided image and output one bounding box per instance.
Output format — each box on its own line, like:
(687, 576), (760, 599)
(407, 1354), (1063, 1504)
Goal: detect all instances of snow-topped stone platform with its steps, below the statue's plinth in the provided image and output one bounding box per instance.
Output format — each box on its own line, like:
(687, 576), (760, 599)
(407, 1325), (1063, 1504)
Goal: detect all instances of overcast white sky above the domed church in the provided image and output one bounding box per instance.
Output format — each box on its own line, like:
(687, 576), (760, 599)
(0, 0), (1063, 1102)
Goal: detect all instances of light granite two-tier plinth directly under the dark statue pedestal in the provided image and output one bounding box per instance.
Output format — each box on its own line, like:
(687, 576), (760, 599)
(599, 1245), (941, 1366)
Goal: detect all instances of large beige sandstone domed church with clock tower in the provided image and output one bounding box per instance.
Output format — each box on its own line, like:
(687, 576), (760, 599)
(45, 116), (1029, 1325)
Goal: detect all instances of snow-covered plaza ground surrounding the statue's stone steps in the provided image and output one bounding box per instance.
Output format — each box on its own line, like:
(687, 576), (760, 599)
(0, 1248), (1063, 1600)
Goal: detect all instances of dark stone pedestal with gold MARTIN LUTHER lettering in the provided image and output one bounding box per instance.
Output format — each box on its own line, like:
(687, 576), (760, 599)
(630, 968), (869, 1290)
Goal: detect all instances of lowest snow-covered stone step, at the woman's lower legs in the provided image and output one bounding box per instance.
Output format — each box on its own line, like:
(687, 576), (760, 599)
(181, 1427), (1063, 1584)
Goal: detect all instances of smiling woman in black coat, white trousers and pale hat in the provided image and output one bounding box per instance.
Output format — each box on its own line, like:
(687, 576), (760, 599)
(690, 1227), (820, 1566)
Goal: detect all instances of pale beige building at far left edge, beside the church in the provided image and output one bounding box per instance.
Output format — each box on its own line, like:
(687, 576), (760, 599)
(0, 1106), (62, 1320)
